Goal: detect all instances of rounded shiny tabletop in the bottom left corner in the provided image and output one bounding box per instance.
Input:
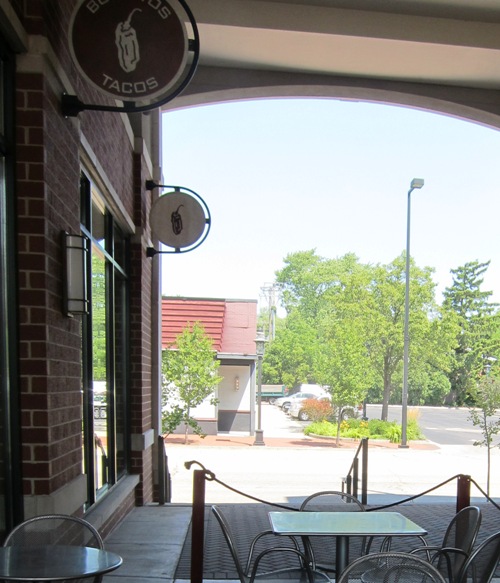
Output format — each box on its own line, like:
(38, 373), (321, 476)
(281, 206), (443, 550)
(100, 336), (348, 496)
(0, 545), (123, 581)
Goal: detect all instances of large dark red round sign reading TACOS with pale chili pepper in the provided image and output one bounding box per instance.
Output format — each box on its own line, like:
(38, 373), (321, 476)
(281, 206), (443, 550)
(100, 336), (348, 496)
(69, 0), (189, 101)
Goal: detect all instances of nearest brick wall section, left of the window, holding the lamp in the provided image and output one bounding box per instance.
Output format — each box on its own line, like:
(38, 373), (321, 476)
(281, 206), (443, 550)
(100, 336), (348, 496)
(16, 67), (81, 495)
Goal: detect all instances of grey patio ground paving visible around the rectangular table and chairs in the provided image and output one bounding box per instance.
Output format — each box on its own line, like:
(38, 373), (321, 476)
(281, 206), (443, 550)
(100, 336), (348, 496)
(100, 501), (500, 583)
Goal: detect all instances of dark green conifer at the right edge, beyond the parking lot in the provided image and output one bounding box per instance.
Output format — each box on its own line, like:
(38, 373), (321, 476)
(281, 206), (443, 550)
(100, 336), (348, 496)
(443, 261), (500, 405)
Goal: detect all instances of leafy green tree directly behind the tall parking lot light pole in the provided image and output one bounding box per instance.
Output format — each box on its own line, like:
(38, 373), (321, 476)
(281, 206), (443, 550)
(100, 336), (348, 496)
(365, 253), (456, 421)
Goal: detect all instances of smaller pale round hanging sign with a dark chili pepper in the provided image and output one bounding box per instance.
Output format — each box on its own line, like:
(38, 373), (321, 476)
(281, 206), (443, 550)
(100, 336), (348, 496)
(149, 190), (210, 251)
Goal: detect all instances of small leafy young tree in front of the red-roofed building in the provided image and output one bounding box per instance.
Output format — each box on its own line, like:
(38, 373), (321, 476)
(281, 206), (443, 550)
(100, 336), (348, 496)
(162, 322), (222, 443)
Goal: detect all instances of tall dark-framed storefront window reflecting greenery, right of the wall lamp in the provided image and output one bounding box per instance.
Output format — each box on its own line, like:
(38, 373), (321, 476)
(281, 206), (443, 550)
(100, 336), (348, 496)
(82, 176), (129, 505)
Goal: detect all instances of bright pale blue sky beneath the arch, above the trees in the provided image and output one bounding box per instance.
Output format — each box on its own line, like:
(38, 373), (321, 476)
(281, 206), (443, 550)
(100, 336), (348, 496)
(160, 98), (500, 314)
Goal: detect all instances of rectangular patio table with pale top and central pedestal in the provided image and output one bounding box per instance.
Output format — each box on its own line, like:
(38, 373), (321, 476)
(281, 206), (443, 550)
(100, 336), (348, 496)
(269, 511), (427, 577)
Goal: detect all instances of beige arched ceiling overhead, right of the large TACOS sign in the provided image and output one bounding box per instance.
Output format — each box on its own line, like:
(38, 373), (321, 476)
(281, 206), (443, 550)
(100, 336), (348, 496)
(164, 0), (500, 127)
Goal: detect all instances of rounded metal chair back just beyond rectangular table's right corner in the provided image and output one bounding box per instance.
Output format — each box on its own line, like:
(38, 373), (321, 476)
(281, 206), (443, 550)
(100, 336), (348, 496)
(436, 506), (482, 581)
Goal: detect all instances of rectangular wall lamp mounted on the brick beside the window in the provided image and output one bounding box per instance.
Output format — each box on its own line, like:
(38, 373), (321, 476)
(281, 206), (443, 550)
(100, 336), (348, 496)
(62, 232), (89, 316)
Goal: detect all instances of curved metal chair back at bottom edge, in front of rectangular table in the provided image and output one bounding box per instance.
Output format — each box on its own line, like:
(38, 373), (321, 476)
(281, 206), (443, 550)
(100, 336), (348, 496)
(336, 553), (446, 583)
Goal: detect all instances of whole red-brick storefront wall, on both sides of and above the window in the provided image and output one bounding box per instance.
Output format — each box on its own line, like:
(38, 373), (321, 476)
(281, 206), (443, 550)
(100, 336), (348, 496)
(16, 0), (152, 503)
